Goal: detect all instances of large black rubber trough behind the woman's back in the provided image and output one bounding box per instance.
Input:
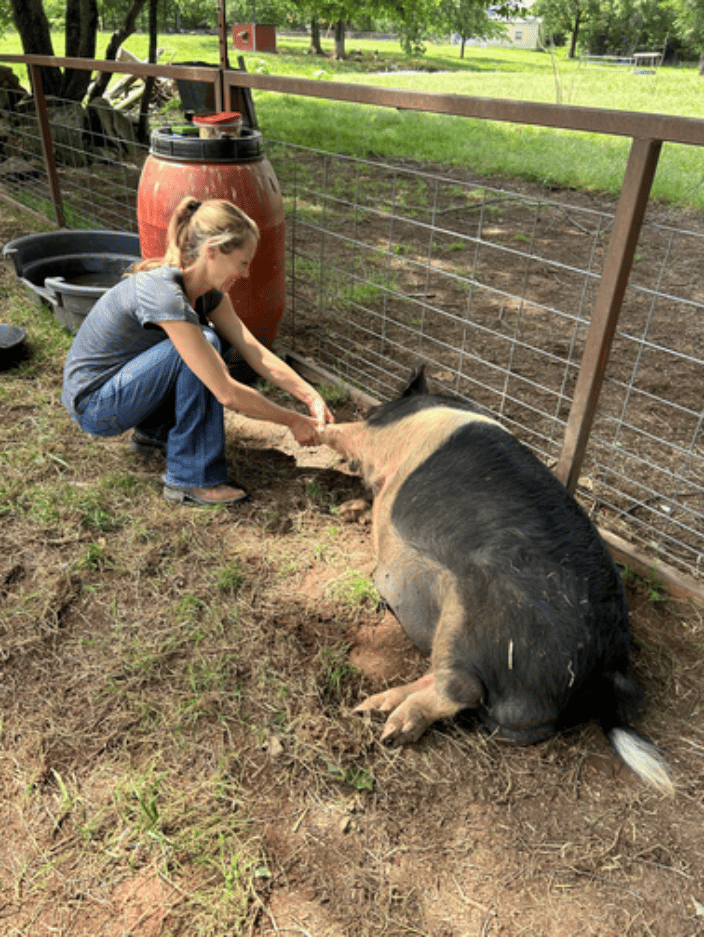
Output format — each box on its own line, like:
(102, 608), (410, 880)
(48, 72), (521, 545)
(2, 230), (141, 332)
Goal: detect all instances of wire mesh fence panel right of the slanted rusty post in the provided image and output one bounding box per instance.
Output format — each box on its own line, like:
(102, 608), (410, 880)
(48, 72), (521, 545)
(589, 218), (704, 574)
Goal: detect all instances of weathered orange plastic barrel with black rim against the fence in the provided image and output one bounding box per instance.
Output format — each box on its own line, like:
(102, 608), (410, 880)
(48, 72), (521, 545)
(137, 127), (286, 348)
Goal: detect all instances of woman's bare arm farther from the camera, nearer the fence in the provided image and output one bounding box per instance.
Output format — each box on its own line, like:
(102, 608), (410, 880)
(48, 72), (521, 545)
(209, 295), (334, 430)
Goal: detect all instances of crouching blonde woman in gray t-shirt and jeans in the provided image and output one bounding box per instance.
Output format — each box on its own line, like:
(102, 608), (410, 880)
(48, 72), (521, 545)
(62, 196), (333, 504)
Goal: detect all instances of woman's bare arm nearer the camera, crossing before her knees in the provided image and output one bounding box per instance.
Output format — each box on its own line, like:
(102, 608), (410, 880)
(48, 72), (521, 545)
(159, 320), (319, 446)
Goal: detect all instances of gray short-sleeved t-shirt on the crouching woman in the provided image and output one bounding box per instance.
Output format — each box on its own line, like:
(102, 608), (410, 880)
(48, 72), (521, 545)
(61, 266), (222, 417)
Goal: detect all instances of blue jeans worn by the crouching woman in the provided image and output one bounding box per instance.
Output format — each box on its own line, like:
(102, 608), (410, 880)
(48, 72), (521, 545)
(78, 327), (232, 488)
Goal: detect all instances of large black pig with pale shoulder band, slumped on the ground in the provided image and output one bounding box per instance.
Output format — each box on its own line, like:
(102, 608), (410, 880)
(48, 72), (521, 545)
(322, 369), (672, 793)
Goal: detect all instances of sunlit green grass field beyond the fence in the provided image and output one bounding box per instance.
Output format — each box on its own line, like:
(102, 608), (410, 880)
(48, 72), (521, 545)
(0, 34), (704, 210)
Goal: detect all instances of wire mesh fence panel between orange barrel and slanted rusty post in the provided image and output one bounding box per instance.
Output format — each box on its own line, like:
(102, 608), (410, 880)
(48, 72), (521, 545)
(270, 147), (610, 458)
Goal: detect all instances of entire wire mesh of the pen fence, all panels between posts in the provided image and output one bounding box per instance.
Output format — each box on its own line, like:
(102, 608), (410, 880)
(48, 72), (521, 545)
(0, 91), (704, 576)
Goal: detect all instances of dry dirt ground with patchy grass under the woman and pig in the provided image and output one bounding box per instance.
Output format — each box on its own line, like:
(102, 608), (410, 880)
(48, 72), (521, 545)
(0, 190), (704, 937)
